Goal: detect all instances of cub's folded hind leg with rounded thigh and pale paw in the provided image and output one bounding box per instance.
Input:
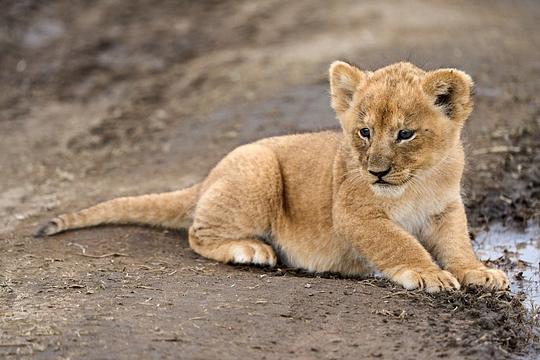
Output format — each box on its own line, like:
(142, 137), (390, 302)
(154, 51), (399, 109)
(189, 144), (282, 266)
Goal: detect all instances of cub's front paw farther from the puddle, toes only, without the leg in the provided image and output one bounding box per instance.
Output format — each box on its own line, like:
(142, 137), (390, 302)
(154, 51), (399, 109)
(390, 268), (459, 293)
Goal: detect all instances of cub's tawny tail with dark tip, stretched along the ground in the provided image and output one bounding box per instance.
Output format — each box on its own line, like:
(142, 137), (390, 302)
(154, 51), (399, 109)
(34, 184), (199, 236)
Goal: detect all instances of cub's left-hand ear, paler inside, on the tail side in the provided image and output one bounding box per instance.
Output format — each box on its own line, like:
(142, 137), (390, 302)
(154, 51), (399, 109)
(328, 61), (367, 114)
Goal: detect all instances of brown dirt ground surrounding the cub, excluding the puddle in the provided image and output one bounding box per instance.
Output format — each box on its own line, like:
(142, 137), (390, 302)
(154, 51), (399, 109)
(0, 0), (540, 359)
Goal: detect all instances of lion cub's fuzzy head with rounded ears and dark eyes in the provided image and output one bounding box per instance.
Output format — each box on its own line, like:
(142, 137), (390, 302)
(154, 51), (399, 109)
(330, 61), (472, 196)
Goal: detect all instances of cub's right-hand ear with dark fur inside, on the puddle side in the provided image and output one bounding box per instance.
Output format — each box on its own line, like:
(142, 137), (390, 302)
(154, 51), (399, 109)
(422, 69), (473, 122)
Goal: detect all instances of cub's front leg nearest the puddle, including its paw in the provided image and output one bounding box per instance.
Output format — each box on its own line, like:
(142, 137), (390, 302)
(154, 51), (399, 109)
(425, 202), (509, 289)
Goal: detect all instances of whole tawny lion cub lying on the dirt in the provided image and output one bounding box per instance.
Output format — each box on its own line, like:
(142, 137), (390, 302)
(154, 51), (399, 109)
(36, 61), (508, 292)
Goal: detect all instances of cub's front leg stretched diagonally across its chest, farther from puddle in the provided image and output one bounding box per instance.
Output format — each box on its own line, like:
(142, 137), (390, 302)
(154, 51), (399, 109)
(334, 202), (459, 292)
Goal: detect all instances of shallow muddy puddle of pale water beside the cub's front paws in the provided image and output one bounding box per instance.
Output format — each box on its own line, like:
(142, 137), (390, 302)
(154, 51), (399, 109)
(473, 224), (540, 308)
